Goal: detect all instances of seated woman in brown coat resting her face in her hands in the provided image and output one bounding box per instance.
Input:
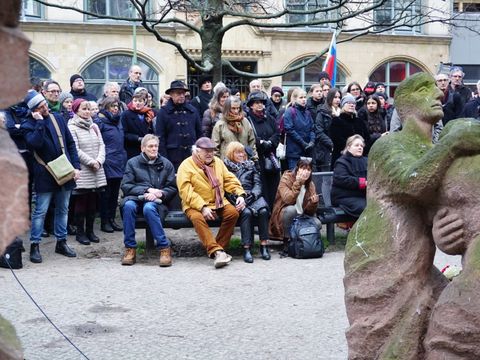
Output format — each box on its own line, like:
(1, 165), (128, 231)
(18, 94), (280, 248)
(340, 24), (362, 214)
(269, 157), (321, 253)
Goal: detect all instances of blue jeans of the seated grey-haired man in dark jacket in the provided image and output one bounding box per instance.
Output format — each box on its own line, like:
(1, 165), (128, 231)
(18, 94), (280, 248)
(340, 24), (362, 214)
(122, 200), (170, 249)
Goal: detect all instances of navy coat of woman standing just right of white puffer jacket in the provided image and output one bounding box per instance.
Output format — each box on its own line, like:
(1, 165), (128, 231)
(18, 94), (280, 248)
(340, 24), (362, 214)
(95, 110), (127, 179)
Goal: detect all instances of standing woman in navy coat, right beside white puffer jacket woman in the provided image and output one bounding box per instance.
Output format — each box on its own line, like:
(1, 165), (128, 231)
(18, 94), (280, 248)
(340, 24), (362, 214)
(96, 97), (127, 233)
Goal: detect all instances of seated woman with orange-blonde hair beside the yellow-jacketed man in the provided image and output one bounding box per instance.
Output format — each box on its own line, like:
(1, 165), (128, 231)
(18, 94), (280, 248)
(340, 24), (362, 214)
(223, 141), (270, 263)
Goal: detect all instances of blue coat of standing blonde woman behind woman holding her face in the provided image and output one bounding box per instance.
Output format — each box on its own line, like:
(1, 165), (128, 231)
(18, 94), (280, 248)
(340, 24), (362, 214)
(283, 104), (315, 159)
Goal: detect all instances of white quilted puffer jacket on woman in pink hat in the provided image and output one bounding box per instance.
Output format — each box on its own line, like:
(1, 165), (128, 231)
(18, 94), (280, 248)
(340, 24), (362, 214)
(68, 115), (107, 189)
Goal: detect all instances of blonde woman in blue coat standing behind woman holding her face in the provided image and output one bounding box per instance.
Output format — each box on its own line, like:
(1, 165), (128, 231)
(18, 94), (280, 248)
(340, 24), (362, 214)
(284, 88), (315, 170)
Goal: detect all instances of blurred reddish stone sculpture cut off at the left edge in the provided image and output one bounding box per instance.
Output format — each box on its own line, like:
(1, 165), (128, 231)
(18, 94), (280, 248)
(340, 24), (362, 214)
(0, 0), (30, 360)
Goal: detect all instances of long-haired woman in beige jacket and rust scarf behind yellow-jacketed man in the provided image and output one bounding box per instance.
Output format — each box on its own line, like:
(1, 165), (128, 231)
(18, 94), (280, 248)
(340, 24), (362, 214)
(212, 96), (258, 162)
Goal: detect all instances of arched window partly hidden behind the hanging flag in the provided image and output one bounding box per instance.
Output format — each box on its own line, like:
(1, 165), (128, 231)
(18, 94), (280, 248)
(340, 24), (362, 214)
(282, 58), (346, 91)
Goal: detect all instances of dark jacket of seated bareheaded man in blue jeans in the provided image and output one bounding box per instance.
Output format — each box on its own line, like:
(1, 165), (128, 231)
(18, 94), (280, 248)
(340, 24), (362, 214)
(121, 153), (177, 204)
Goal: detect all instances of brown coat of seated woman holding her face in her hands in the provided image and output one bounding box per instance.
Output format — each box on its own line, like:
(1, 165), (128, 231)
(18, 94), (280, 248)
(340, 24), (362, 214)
(268, 170), (318, 240)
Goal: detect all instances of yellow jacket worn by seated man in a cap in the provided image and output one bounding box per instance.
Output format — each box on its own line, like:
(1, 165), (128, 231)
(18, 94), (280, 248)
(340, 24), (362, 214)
(177, 156), (245, 211)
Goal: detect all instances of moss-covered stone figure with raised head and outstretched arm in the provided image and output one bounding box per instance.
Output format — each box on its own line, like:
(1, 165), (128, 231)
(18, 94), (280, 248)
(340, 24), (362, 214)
(344, 73), (480, 360)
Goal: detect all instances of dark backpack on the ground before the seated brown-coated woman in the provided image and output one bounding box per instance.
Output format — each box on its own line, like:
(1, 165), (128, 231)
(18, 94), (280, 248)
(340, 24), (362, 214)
(288, 214), (325, 259)
